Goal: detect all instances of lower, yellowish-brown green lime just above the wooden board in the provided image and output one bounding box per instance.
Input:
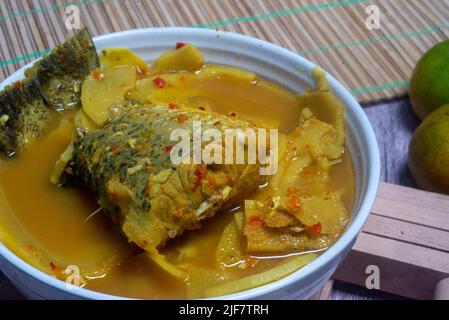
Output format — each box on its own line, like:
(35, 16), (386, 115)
(408, 104), (449, 194)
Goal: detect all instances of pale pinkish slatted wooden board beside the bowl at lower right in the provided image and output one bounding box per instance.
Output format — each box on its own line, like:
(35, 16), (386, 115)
(333, 183), (449, 299)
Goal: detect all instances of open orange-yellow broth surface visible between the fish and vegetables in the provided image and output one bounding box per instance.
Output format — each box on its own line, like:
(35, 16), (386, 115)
(0, 66), (354, 298)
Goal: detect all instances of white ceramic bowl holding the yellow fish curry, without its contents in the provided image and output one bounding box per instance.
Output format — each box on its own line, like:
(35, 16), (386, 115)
(0, 28), (380, 299)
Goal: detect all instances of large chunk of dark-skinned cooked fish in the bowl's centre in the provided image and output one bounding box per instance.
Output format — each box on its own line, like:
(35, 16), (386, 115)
(60, 106), (264, 252)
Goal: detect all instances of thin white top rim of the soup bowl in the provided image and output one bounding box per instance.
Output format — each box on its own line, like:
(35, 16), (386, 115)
(0, 27), (380, 300)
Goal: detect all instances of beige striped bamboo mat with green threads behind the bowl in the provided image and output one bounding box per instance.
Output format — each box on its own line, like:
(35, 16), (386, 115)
(0, 0), (449, 102)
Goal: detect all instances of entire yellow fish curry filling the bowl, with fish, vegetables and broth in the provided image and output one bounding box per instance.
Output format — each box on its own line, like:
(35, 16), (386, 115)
(0, 30), (354, 298)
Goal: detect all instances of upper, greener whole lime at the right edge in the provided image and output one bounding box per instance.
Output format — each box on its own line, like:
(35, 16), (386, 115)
(409, 40), (449, 120)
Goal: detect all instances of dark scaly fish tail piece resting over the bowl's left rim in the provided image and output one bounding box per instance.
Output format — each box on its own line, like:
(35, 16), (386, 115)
(0, 29), (99, 155)
